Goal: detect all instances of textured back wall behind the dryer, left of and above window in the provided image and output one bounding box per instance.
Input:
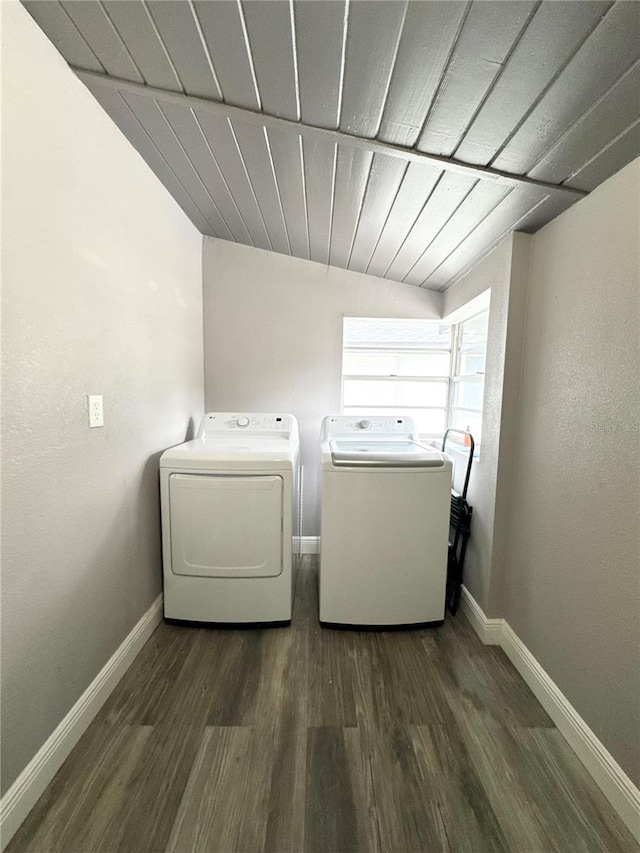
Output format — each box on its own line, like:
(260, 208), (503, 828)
(203, 238), (441, 536)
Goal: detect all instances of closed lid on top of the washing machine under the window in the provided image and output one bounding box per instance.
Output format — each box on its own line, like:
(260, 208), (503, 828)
(329, 439), (446, 468)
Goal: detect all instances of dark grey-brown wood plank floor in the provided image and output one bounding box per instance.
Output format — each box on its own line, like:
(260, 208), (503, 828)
(7, 558), (640, 853)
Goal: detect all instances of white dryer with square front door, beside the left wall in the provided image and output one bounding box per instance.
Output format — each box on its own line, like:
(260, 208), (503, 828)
(160, 412), (299, 623)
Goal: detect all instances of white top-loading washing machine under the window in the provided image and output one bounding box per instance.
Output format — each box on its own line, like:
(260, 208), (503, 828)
(319, 415), (452, 626)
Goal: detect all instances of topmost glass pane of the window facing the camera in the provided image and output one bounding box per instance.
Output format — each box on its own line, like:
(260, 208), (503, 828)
(344, 317), (451, 349)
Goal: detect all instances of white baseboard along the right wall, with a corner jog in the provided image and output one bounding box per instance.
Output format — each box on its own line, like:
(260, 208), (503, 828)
(461, 587), (640, 842)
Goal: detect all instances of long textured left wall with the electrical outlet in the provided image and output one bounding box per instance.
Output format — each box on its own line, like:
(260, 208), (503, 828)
(2, 3), (203, 790)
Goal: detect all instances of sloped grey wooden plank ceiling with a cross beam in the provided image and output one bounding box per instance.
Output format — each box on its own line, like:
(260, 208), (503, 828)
(24, 0), (640, 290)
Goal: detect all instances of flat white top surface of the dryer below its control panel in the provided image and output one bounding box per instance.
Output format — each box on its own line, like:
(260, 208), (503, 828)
(160, 433), (298, 471)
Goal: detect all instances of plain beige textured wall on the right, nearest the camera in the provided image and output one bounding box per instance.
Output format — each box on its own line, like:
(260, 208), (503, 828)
(503, 160), (640, 783)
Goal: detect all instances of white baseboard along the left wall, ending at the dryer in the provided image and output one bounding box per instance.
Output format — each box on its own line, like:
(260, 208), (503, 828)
(0, 595), (162, 850)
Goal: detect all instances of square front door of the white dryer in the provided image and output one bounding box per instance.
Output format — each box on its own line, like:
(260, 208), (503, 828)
(169, 474), (283, 578)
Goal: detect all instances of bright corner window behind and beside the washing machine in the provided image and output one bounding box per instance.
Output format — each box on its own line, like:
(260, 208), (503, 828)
(342, 312), (488, 444)
